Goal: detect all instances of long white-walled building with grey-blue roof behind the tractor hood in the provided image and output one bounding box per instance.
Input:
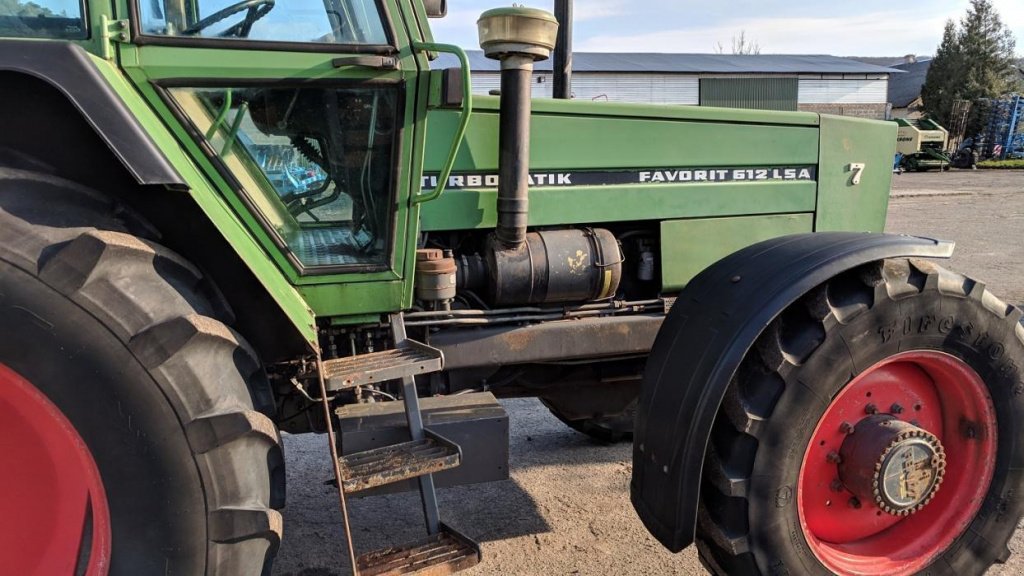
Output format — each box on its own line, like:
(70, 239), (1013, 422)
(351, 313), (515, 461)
(435, 50), (901, 118)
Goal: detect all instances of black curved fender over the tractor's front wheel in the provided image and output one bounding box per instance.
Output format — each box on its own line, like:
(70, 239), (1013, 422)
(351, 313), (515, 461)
(630, 233), (953, 551)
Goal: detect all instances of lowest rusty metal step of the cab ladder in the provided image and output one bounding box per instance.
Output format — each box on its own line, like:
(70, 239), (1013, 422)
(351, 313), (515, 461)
(356, 524), (480, 576)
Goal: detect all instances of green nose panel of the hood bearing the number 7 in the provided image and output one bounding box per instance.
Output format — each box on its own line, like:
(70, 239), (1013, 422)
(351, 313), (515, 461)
(814, 115), (896, 232)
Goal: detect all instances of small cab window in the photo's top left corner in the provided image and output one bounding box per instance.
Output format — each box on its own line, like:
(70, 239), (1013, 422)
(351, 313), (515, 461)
(0, 0), (88, 40)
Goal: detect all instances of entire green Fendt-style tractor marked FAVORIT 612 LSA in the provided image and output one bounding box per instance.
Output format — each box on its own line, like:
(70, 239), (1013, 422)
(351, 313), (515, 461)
(0, 0), (1024, 576)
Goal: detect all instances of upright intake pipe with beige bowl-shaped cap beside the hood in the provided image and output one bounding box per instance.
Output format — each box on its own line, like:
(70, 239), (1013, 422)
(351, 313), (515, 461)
(476, 7), (558, 250)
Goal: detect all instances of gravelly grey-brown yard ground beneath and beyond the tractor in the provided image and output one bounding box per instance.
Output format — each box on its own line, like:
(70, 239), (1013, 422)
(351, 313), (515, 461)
(273, 171), (1024, 576)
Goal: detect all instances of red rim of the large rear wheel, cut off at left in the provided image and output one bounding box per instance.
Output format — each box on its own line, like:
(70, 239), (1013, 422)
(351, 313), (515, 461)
(0, 364), (111, 576)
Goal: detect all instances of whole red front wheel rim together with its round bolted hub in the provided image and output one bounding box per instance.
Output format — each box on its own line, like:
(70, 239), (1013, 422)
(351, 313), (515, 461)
(797, 349), (998, 576)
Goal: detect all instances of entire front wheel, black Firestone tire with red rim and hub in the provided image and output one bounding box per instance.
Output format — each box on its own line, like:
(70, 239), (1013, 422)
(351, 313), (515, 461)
(697, 260), (1024, 576)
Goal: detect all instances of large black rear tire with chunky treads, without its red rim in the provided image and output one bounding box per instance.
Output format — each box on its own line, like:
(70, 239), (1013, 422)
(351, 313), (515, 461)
(0, 168), (285, 575)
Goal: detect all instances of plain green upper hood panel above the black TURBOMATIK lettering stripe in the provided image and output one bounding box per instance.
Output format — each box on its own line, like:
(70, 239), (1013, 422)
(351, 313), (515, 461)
(425, 97), (818, 172)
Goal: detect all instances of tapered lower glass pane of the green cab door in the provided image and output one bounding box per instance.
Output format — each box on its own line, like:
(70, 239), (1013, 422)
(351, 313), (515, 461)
(169, 84), (400, 273)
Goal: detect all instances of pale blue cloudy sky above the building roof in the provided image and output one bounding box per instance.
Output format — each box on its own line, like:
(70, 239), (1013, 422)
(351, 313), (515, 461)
(431, 0), (1024, 56)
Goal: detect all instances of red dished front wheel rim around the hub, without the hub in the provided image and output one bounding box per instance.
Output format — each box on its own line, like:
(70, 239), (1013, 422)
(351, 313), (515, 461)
(797, 351), (997, 576)
